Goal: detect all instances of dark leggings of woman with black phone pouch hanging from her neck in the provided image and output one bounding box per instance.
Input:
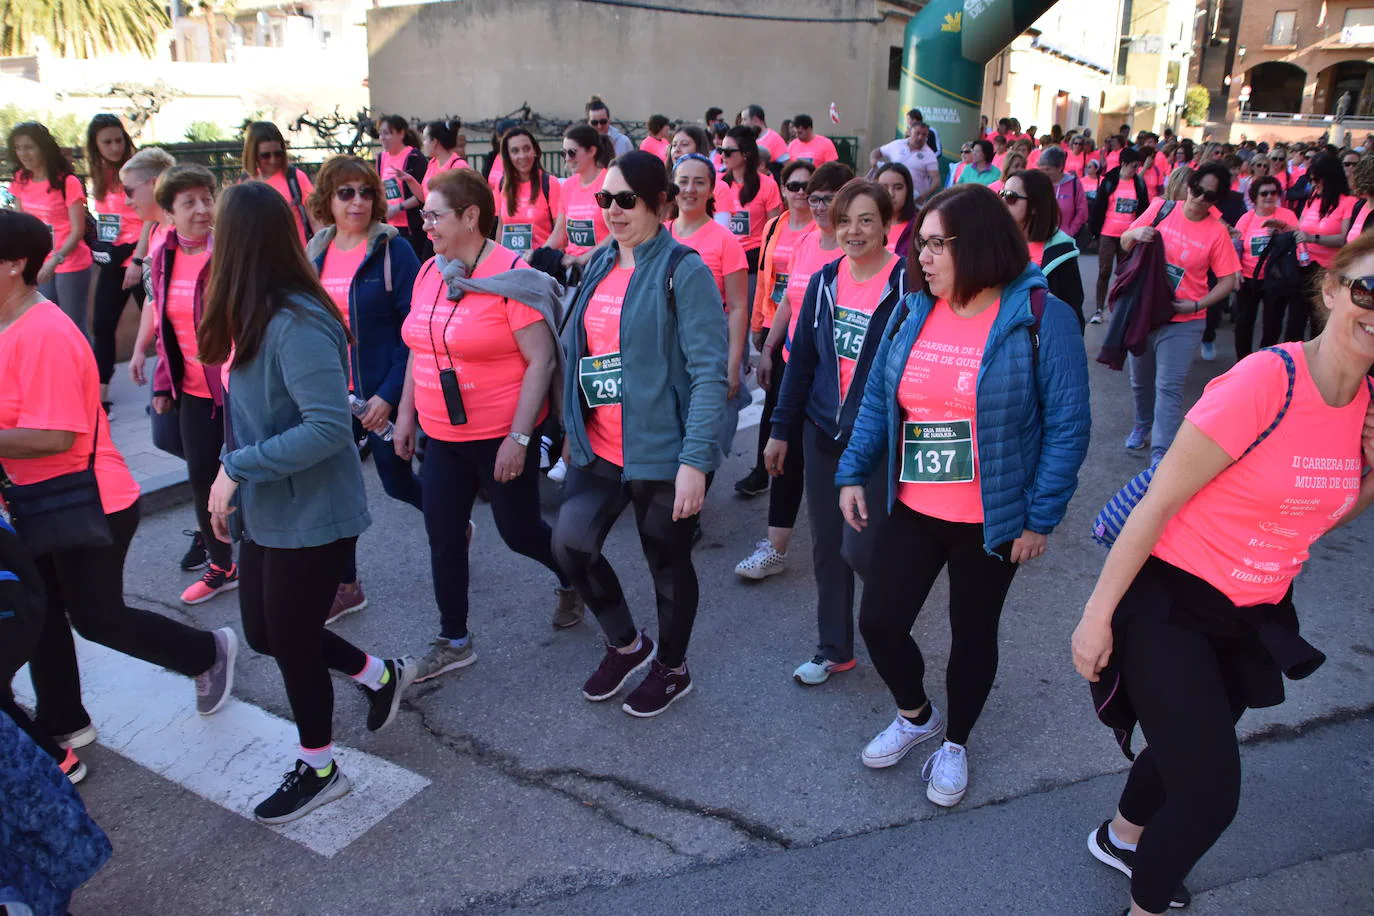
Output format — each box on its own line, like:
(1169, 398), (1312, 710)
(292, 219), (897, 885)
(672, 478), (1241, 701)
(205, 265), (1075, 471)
(420, 438), (567, 640)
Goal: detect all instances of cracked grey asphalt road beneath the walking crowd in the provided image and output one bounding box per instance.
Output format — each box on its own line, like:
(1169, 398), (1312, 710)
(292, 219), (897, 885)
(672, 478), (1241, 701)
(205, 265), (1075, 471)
(48, 260), (1374, 916)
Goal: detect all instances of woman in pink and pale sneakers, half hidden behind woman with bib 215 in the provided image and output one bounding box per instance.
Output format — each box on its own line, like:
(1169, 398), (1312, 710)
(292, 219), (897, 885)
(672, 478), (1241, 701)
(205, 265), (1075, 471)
(735, 162), (855, 580)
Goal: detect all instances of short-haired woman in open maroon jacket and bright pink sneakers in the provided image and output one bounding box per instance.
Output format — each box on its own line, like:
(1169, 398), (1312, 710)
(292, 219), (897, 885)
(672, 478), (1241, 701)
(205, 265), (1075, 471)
(129, 165), (239, 604)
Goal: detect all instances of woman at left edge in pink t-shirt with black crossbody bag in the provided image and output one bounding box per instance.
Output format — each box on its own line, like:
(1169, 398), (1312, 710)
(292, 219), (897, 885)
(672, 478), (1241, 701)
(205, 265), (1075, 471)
(0, 210), (238, 783)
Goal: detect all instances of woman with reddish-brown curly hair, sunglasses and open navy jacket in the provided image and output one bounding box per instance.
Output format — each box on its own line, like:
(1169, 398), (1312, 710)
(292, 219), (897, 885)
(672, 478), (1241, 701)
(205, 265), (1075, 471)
(305, 155), (420, 623)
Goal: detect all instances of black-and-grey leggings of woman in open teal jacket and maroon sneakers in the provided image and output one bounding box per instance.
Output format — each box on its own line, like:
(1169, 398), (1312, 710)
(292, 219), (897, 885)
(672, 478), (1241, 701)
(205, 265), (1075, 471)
(554, 459), (701, 667)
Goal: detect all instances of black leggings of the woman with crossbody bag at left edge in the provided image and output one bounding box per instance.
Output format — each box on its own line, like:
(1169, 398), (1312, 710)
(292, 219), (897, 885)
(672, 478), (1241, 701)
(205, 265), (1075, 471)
(29, 503), (216, 735)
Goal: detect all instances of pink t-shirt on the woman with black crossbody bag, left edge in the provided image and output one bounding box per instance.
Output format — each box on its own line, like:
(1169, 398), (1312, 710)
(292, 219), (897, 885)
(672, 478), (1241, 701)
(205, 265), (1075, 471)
(0, 302), (139, 515)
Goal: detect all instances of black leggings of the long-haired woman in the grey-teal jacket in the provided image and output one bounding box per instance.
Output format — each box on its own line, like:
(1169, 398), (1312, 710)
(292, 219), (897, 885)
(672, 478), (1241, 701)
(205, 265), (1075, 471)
(239, 537), (367, 748)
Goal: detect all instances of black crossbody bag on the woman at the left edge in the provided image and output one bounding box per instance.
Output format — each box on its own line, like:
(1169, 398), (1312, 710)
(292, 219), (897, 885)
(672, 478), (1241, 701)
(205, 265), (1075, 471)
(0, 405), (114, 556)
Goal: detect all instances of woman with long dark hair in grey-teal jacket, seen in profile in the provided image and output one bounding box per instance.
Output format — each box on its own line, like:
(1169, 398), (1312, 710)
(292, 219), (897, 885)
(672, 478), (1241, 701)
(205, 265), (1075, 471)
(196, 181), (415, 824)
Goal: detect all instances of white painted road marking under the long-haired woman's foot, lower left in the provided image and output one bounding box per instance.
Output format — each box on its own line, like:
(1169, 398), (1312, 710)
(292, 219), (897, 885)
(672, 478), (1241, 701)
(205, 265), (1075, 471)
(15, 637), (430, 856)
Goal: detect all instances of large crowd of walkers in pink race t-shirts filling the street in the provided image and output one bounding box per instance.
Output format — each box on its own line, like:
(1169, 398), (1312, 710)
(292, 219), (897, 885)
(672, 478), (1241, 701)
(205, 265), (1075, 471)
(0, 96), (1374, 915)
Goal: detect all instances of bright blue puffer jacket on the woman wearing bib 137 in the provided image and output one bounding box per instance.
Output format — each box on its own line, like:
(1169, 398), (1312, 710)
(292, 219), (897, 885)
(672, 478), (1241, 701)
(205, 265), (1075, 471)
(835, 265), (1092, 555)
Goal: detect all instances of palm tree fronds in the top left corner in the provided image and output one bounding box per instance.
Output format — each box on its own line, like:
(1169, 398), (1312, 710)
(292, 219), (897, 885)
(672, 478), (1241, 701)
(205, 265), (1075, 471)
(0, 0), (169, 58)
